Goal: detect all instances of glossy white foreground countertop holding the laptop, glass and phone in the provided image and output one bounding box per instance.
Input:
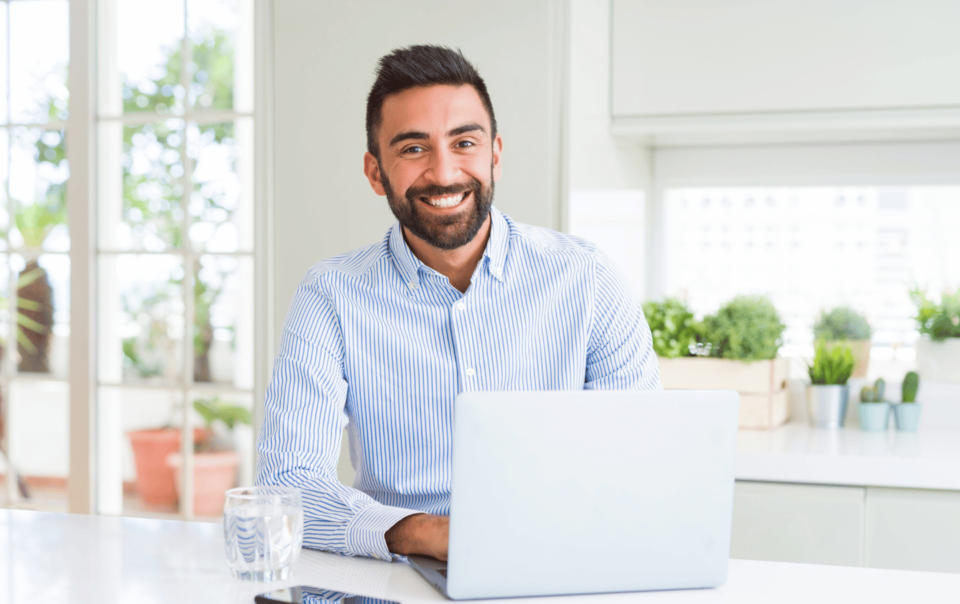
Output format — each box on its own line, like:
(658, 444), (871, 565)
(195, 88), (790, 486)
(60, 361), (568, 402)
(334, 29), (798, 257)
(0, 510), (960, 604)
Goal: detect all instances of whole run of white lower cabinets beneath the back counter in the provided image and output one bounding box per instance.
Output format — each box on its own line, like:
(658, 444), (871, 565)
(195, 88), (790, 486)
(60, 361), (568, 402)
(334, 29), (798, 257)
(730, 481), (960, 573)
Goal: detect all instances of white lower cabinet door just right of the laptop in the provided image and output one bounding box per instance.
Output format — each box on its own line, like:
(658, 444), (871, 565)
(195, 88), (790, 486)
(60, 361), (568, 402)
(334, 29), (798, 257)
(730, 481), (865, 566)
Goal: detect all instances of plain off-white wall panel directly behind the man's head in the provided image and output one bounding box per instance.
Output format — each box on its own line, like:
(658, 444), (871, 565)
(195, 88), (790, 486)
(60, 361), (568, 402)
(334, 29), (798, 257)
(273, 0), (566, 340)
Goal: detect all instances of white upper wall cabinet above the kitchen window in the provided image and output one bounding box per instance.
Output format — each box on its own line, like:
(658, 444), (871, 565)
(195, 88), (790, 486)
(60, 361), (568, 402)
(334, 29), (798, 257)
(611, 0), (960, 116)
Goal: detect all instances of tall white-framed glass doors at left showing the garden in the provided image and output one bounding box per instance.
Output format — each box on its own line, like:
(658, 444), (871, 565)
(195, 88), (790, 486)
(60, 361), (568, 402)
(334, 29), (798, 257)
(0, 0), (255, 518)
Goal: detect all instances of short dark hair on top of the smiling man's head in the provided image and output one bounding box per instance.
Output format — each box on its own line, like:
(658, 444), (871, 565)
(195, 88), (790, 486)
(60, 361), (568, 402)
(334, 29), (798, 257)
(367, 44), (497, 159)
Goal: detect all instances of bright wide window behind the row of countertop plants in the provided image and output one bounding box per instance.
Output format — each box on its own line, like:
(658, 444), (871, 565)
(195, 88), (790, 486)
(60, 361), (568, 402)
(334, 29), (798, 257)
(663, 186), (960, 380)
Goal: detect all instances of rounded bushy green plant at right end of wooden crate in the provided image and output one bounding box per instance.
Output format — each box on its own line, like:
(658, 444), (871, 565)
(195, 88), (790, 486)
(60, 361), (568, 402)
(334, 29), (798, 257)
(702, 296), (785, 361)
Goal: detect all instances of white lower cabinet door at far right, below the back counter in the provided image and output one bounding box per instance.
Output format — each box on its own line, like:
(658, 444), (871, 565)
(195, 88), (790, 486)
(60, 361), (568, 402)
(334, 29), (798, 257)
(865, 487), (960, 573)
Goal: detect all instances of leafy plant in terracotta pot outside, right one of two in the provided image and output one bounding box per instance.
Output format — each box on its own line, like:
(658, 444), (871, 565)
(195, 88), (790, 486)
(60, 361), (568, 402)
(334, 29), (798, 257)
(166, 398), (251, 516)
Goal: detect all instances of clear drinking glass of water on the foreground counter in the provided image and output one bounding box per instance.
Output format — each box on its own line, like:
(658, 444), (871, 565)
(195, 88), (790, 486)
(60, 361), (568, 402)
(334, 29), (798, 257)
(223, 486), (303, 582)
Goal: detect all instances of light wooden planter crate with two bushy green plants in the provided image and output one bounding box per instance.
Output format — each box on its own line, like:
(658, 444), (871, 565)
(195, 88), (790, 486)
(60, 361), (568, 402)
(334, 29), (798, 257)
(647, 296), (790, 429)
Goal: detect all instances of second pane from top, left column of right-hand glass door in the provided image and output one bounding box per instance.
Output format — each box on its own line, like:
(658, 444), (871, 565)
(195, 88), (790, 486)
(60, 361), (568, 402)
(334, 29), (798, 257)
(100, 119), (184, 252)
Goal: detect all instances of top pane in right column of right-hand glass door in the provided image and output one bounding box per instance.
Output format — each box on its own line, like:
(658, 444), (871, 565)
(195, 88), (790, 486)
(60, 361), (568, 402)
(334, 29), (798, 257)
(187, 0), (244, 110)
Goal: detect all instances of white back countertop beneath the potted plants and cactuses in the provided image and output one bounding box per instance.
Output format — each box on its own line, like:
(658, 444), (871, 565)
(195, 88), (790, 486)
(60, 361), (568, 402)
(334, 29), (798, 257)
(736, 423), (960, 491)
